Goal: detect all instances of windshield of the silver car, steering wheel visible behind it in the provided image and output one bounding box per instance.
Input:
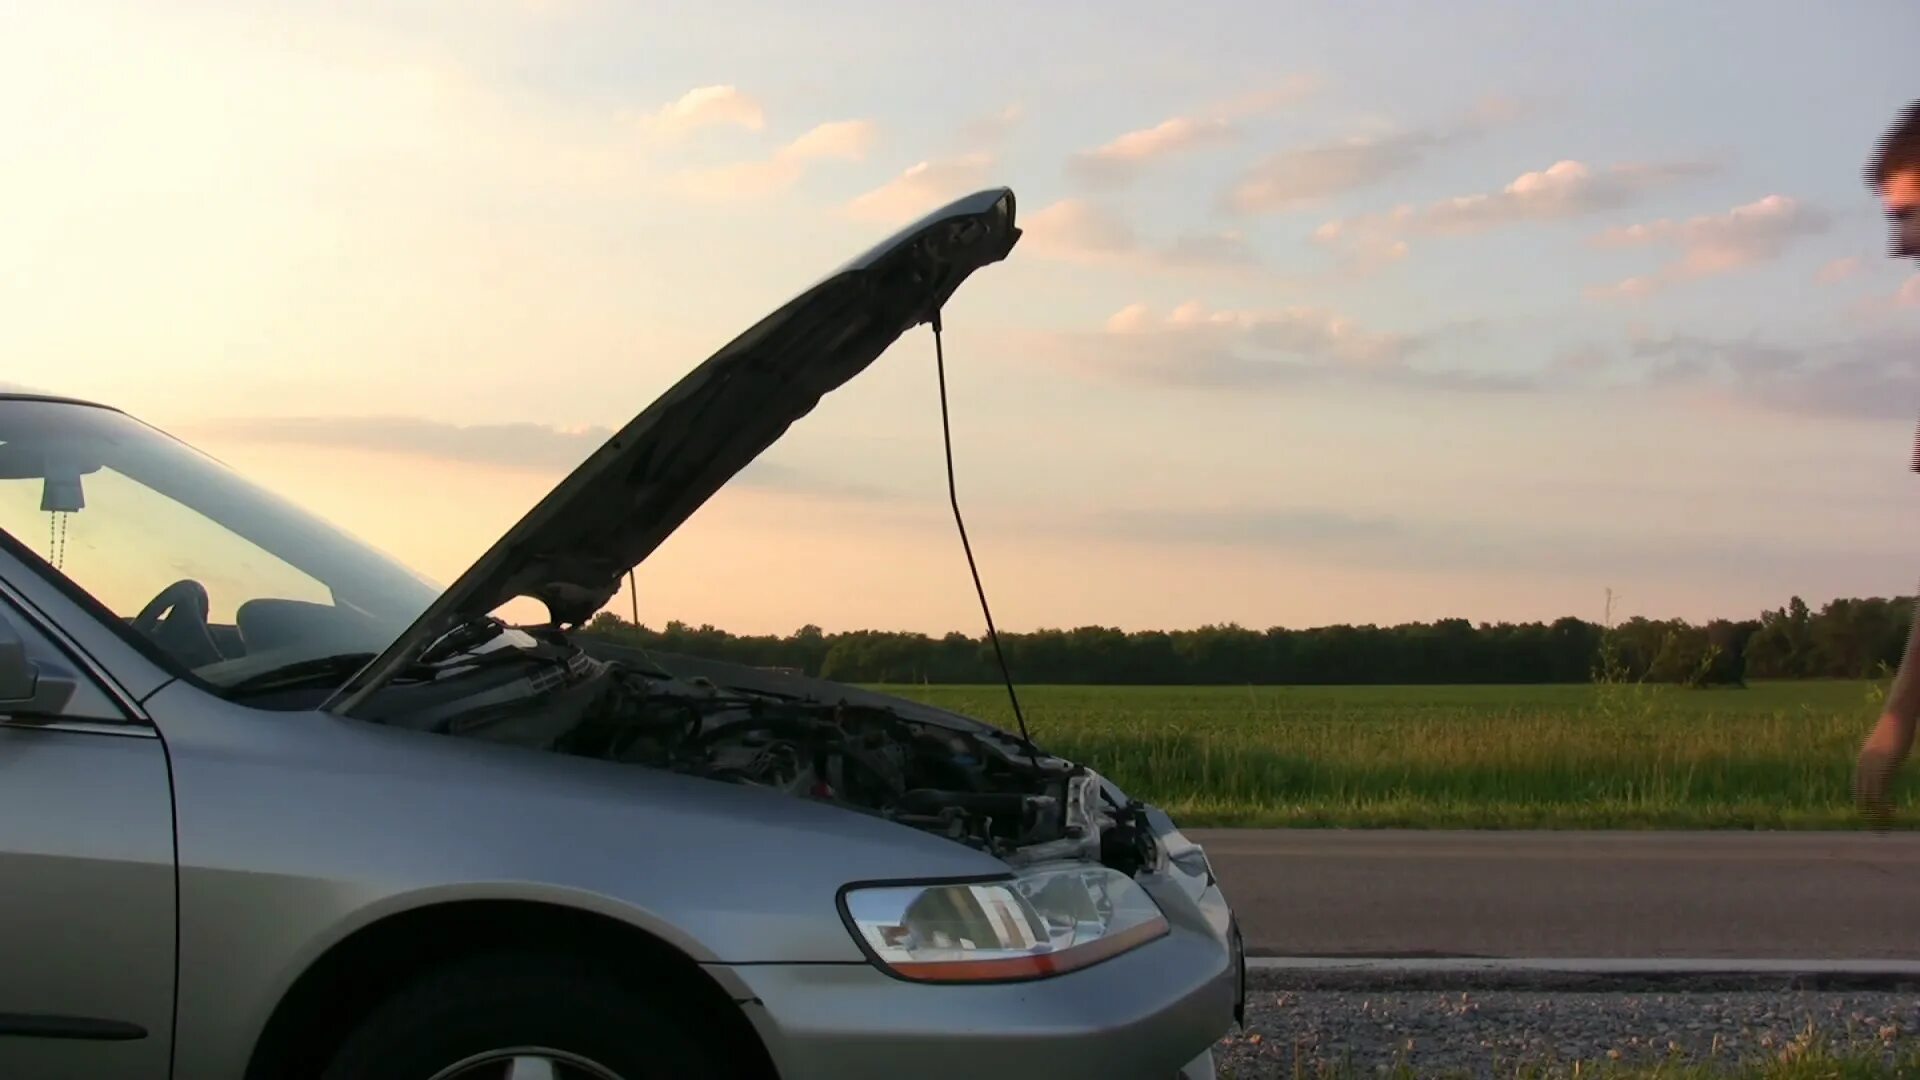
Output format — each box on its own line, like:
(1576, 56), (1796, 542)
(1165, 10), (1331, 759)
(0, 398), (440, 688)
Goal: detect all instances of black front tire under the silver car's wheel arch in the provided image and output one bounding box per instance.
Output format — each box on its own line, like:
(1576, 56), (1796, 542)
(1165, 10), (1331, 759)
(323, 953), (735, 1080)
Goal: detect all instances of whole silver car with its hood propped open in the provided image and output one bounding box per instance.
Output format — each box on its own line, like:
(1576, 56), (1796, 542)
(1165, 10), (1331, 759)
(0, 190), (1244, 1080)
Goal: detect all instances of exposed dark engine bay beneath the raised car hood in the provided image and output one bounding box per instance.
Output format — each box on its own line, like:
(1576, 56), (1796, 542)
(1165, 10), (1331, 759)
(386, 650), (1154, 874)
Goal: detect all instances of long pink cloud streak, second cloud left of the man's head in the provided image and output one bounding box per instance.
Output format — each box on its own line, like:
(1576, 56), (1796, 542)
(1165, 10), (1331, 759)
(1313, 160), (1715, 261)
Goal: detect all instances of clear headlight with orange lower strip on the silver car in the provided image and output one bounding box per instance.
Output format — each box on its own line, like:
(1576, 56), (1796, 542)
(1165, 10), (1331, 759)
(841, 867), (1167, 982)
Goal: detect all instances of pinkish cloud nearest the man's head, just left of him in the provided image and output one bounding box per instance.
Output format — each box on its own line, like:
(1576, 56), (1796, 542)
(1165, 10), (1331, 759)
(1594, 194), (1832, 296)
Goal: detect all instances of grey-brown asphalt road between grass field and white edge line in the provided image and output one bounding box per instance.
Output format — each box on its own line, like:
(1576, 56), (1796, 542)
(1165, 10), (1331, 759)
(1187, 828), (1920, 959)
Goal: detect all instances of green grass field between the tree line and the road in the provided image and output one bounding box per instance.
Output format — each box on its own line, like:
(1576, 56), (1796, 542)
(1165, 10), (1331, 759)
(883, 682), (1920, 828)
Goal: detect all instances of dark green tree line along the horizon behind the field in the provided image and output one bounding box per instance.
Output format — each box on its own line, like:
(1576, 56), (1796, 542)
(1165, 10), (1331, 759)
(586, 596), (1914, 686)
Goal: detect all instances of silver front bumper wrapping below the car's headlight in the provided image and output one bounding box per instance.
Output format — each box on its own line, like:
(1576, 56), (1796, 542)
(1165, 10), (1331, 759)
(708, 818), (1246, 1080)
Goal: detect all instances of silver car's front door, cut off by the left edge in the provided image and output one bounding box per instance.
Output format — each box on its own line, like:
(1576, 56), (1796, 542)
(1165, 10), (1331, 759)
(0, 594), (175, 1080)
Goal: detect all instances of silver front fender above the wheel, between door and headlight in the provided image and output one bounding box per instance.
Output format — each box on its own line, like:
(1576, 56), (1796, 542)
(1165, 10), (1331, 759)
(148, 682), (1029, 1076)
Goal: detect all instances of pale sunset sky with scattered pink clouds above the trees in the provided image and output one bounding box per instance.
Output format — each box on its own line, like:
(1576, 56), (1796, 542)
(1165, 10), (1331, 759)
(0, 0), (1920, 632)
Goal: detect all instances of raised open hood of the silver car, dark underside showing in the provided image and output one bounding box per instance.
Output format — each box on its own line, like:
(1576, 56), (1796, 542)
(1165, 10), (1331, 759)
(326, 188), (1020, 713)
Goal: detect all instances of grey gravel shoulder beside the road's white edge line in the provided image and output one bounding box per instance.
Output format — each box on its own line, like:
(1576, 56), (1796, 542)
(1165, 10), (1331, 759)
(1215, 972), (1920, 1080)
